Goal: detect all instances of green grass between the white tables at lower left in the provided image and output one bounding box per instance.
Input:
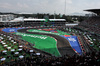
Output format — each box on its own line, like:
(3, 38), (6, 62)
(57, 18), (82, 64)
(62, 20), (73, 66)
(0, 37), (30, 62)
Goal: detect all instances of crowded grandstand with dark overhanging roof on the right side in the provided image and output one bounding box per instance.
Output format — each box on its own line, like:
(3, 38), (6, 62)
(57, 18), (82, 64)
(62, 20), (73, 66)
(74, 9), (100, 35)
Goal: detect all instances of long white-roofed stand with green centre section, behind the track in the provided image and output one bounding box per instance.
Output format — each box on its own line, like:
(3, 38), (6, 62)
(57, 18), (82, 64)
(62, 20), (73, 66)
(24, 19), (66, 26)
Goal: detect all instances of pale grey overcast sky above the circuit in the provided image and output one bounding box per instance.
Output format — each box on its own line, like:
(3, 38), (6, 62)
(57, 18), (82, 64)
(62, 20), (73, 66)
(0, 0), (100, 15)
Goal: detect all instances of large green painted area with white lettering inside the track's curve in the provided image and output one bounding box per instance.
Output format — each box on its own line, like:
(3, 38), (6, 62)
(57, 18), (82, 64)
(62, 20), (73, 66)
(15, 32), (61, 57)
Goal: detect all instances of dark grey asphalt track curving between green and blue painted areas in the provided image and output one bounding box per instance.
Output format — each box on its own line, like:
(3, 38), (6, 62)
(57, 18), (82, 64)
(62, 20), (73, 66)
(18, 28), (75, 57)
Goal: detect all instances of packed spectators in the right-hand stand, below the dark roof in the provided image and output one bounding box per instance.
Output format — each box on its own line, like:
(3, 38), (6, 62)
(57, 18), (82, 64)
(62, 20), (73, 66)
(77, 16), (100, 34)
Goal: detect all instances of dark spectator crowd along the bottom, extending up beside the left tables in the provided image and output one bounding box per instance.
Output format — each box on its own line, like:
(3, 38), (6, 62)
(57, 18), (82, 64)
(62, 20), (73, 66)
(0, 26), (100, 66)
